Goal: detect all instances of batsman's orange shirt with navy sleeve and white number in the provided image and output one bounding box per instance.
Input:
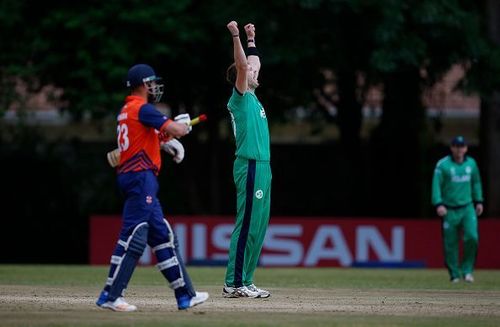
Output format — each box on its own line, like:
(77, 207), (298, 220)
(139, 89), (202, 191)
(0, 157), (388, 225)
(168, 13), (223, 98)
(117, 95), (172, 175)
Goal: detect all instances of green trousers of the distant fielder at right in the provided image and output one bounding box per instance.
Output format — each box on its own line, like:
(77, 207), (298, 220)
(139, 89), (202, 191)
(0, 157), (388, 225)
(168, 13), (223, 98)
(443, 203), (479, 279)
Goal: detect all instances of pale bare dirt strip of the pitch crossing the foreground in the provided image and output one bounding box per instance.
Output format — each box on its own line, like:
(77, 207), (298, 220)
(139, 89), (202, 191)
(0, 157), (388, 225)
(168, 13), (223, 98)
(0, 285), (500, 317)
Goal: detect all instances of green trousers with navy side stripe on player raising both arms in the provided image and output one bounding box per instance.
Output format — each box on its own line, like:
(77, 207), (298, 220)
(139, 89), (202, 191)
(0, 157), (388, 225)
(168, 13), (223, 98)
(225, 158), (272, 287)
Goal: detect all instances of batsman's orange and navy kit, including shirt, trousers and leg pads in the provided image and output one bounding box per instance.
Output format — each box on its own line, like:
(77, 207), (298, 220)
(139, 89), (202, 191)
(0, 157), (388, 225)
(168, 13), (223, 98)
(108, 96), (196, 303)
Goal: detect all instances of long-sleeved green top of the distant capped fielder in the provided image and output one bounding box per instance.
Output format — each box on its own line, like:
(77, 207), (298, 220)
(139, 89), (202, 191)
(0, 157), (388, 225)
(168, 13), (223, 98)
(432, 155), (483, 207)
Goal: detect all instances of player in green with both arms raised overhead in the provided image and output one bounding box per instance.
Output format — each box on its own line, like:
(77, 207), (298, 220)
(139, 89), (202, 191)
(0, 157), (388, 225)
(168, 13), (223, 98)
(222, 21), (272, 298)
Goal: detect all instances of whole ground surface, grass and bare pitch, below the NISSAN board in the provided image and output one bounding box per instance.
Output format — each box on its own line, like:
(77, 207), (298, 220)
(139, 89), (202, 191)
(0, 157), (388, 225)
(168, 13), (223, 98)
(0, 265), (500, 327)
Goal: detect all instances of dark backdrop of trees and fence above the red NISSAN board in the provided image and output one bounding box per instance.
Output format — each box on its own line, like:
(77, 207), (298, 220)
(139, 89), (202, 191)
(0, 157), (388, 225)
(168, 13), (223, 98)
(0, 0), (500, 262)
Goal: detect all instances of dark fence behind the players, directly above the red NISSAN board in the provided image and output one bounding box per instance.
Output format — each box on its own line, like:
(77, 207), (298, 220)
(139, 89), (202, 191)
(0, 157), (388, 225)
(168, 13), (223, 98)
(0, 138), (474, 263)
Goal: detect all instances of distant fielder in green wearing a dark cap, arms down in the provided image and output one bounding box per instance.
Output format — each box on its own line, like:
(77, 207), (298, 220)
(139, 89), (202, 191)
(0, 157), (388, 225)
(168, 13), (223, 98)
(432, 136), (483, 283)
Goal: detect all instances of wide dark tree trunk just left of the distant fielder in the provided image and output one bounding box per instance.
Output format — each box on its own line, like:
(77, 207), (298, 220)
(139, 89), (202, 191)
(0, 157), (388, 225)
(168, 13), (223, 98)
(371, 69), (428, 217)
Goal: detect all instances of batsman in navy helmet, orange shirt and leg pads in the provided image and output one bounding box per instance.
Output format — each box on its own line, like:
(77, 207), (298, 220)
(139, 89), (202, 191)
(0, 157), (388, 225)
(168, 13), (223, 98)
(96, 64), (208, 311)
